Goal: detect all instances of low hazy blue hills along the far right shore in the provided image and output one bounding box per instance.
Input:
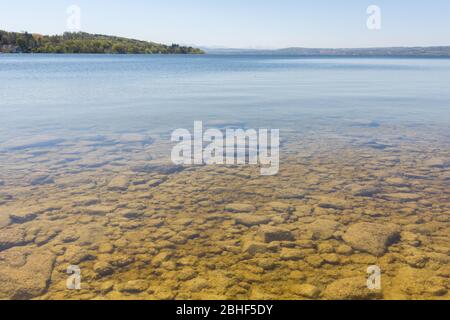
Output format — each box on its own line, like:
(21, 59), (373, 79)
(203, 46), (450, 57)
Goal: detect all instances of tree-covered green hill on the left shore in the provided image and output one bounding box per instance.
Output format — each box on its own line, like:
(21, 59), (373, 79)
(0, 30), (204, 54)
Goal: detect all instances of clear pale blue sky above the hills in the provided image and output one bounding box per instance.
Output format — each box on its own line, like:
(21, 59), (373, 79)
(0, 0), (450, 49)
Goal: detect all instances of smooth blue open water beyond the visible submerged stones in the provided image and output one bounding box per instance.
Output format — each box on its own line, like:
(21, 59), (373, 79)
(0, 55), (450, 140)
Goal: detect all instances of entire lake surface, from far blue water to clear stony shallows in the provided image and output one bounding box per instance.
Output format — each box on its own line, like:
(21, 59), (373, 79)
(0, 55), (450, 299)
